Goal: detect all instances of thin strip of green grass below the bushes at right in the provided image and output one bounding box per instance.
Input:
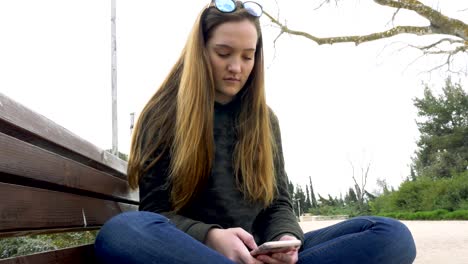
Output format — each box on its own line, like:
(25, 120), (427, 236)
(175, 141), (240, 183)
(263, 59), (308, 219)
(378, 209), (468, 220)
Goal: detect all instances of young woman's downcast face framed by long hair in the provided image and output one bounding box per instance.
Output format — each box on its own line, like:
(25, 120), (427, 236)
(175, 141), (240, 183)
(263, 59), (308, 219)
(206, 20), (258, 104)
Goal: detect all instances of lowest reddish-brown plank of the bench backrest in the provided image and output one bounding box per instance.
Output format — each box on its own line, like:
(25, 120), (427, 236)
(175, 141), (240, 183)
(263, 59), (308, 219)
(0, 183), (137, 233)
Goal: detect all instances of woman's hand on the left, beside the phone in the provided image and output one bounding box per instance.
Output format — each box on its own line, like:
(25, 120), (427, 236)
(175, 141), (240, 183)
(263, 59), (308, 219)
(205, 228), (263, 264)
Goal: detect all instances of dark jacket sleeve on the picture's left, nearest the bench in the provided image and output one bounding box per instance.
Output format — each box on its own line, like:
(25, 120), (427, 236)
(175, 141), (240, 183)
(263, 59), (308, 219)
(139, 155), (221, 243)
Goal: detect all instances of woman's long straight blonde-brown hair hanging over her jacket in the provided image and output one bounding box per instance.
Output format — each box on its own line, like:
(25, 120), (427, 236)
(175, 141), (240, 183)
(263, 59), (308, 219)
(128, 3), (276, 211)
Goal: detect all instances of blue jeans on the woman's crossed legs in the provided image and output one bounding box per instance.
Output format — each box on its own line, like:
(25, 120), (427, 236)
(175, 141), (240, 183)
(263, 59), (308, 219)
(95, 211), (416, 264)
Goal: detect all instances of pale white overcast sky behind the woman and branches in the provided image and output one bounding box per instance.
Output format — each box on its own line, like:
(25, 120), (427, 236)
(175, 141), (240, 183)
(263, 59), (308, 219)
(0, 0), (468, 196)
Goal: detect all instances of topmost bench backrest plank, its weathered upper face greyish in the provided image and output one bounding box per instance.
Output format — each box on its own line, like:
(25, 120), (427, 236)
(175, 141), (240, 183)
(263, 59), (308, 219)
(0, 93), (127, 175)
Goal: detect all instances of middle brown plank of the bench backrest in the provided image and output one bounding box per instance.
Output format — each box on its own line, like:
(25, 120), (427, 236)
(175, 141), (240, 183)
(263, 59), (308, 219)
(0, 133), (138, 204)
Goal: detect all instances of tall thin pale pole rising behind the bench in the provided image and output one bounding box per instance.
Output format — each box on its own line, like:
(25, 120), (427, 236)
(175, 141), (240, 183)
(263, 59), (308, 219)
(111, 0), (119, 156)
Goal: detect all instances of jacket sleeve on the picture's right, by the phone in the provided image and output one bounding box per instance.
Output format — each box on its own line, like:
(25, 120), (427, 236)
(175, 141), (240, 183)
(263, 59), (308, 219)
(250, 110), (304, 242)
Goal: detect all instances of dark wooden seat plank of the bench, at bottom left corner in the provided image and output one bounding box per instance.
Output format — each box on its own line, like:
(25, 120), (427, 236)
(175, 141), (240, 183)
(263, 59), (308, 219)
(0, 244), (96, 264)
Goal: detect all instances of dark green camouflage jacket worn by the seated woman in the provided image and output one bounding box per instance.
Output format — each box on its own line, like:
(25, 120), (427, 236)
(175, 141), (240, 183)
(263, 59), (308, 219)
(139, 100), (304, 244)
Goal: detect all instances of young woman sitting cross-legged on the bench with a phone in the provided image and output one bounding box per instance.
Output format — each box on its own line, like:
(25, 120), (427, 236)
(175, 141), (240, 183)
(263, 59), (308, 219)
(95, 0), (415, 264)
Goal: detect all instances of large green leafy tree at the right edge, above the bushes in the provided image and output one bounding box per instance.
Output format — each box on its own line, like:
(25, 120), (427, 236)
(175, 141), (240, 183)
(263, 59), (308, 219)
(413, 78), (468, 179)
